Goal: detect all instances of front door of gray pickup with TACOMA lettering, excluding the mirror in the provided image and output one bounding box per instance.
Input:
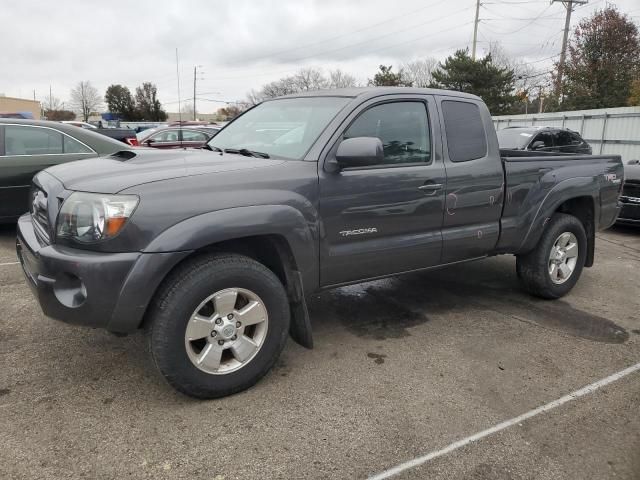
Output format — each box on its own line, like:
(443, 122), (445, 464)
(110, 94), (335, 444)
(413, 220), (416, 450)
(320, 95), (446, 286)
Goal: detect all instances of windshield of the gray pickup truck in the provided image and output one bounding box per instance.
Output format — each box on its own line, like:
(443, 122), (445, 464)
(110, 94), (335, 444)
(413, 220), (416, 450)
(208, 97), (350, 160)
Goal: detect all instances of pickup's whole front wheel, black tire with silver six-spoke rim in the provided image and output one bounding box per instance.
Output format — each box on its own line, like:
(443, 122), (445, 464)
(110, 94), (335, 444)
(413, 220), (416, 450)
(148, 255), (290, 398)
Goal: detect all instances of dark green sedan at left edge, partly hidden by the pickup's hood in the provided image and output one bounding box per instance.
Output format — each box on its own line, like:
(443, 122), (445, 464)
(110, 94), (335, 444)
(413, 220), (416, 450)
(0, 119), (131, 222)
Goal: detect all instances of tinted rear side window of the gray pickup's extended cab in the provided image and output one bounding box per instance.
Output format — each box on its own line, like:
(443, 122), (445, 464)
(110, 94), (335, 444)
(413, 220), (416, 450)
(441, 100), (487, 162)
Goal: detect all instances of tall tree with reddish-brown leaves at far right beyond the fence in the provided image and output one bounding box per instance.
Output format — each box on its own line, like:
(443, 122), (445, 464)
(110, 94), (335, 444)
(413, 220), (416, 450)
(562, 6), (640, 110)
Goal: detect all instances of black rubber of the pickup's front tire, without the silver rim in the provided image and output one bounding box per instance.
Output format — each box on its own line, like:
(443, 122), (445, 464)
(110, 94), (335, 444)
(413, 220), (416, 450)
(150, 256), (290, 398)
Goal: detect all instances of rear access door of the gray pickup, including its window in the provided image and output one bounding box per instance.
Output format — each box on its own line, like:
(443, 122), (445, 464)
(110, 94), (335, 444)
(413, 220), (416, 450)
(438, 97), (504, 263)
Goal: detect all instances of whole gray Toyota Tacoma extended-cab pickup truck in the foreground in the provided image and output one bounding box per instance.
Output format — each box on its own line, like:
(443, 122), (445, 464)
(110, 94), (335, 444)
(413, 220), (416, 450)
(17, 88), (623, 398)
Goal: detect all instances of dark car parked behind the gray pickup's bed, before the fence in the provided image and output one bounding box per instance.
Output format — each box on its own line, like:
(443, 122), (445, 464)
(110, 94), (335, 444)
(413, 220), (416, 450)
(496, 127), (591, 155)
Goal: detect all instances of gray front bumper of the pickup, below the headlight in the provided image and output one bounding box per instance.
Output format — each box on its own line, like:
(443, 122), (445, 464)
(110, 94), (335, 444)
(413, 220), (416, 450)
(16, 214), (190, 333)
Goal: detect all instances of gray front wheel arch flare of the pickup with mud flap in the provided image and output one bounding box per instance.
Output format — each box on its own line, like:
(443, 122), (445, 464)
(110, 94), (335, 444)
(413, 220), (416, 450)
(108, 205), (318, 348)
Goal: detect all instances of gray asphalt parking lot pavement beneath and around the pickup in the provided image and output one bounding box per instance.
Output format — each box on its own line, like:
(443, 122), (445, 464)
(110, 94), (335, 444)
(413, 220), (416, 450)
(0, 226), (640, 480)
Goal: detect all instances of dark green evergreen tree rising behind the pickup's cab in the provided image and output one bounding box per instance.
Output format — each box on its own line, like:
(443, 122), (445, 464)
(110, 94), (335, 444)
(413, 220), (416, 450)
(431, 50), (518, 115)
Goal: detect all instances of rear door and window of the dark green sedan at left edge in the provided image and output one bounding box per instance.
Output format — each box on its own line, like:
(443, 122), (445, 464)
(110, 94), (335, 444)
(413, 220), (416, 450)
(0, 124), (97, 217)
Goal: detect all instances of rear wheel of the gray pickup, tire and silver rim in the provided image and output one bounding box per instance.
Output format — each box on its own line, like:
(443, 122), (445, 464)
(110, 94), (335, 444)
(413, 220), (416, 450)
(516, 213), (587, 299)
